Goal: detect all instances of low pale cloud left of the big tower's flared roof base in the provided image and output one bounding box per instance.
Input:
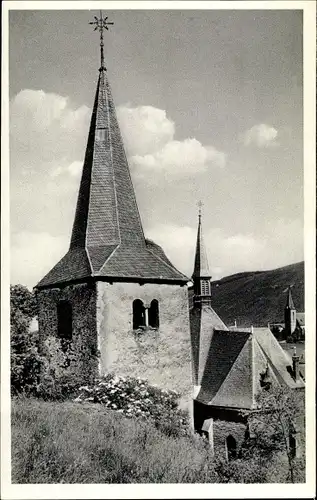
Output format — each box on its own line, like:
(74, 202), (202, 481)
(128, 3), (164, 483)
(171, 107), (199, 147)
(10, 231), (69, 288)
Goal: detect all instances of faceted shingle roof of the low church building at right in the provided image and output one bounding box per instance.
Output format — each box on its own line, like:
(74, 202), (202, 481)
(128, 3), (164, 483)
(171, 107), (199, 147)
(196, 328), (304, 409)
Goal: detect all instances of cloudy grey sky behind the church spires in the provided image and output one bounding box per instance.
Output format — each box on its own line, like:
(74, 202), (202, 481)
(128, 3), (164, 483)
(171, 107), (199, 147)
(9, 6), (304, 287)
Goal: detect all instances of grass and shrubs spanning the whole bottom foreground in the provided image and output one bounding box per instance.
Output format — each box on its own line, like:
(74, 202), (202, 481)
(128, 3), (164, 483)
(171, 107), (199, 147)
(11, 393), (305, 484)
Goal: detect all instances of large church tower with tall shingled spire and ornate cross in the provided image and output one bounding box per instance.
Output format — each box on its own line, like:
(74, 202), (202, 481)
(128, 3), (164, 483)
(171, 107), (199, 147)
(36, 14), (191, 400)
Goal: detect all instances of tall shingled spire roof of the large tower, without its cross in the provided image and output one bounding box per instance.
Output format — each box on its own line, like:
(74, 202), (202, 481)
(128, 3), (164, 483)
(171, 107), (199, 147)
(37, 68), (188, 287)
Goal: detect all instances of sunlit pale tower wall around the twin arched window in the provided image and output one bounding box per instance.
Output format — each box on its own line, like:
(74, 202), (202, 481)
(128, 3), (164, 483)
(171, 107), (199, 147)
(97, 282), (192, 400)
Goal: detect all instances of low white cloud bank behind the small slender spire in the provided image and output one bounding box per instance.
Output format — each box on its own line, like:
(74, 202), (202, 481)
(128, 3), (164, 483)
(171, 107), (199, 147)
(146, 219), (304, 280)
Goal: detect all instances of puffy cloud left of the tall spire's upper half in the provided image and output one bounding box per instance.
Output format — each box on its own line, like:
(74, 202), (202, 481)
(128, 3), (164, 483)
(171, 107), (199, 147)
(10, 89), (90, 171)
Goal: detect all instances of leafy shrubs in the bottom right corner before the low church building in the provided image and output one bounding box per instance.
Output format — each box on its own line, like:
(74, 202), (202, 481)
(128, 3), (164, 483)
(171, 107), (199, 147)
(228, 386), (305, 483)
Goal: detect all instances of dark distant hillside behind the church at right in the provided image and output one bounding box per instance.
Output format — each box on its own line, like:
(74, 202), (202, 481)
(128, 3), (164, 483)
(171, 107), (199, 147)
(190, 262), (304, 327)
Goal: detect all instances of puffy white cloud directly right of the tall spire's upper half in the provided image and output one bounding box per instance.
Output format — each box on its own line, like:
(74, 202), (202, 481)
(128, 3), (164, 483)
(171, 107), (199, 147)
(118, 106), (226, 179)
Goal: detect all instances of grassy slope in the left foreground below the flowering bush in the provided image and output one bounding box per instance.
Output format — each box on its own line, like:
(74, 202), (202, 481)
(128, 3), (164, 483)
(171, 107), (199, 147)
(12, 398), (217, 484)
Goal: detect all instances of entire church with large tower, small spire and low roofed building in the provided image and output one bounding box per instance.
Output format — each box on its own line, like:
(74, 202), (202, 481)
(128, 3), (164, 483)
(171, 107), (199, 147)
(36, 16), (304, 460)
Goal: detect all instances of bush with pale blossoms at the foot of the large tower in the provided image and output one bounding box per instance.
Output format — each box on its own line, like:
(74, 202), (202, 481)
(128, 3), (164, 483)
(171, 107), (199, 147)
(75, 374), (189, 436)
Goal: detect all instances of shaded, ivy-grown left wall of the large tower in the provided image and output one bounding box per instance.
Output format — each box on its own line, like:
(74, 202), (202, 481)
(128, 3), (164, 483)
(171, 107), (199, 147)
(37, 284), (98, 381)
